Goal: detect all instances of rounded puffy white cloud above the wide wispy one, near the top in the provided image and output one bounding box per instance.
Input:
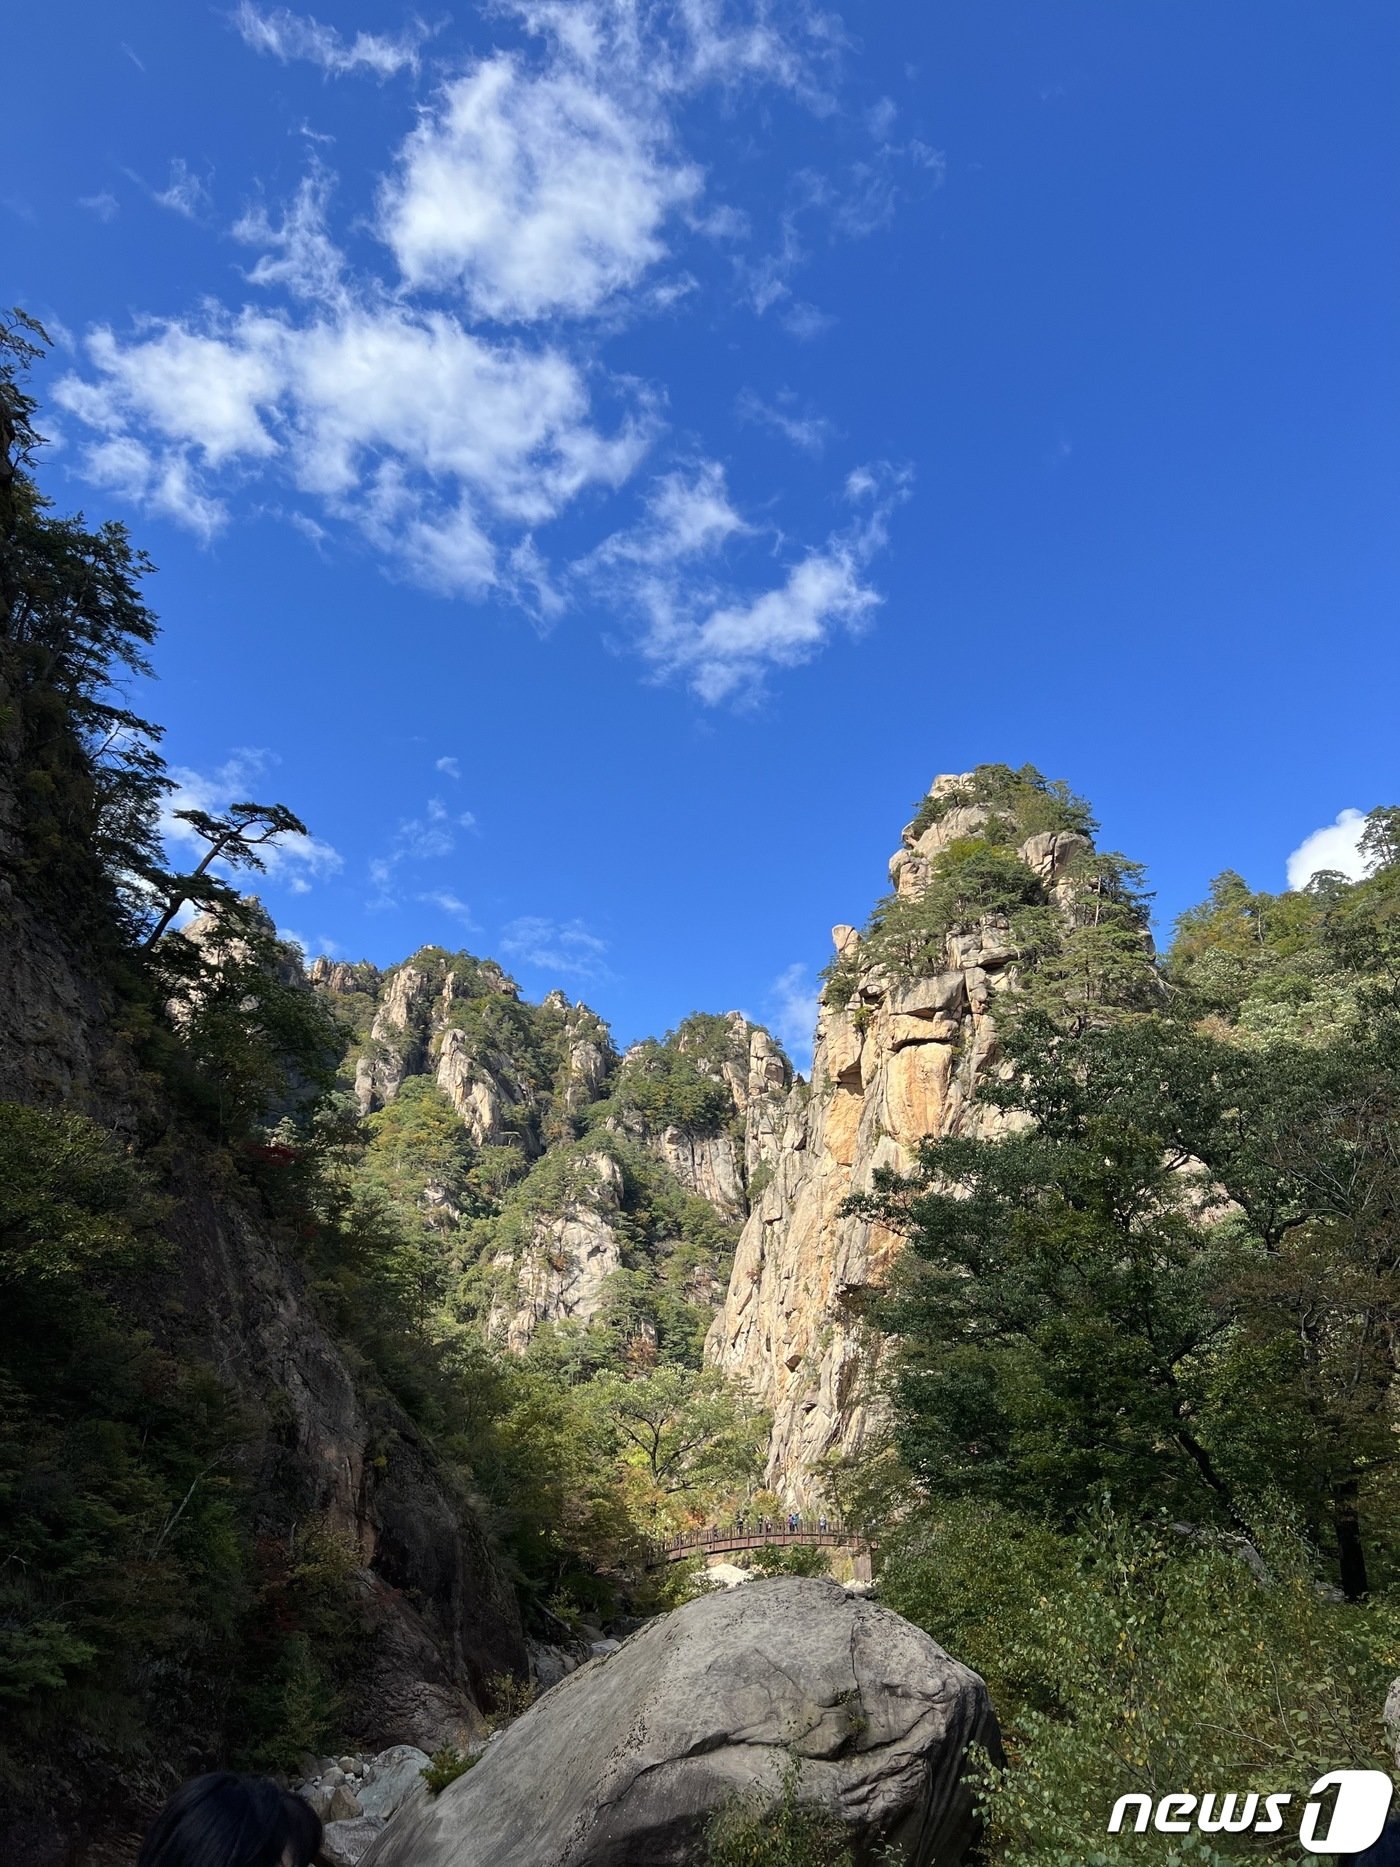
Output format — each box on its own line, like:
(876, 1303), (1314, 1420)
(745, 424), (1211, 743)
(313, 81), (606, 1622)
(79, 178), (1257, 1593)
(381, 54), (702, 321)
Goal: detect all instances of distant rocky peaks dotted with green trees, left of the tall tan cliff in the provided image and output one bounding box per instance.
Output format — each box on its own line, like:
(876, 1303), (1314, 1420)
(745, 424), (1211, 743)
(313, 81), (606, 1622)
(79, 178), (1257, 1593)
(312, 947), (793, 1352)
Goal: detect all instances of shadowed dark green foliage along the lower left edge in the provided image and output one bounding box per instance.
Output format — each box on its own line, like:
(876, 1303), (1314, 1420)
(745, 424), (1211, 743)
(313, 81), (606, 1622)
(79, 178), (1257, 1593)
(0, 1105), (246, 1772)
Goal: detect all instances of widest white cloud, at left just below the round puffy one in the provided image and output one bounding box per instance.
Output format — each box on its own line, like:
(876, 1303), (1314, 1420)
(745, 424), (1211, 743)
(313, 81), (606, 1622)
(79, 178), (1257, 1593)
(54, 302), (655, 596)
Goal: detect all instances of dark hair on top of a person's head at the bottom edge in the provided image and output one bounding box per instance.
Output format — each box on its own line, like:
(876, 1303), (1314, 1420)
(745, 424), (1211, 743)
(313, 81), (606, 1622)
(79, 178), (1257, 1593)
(136, 1770), (321, 1867)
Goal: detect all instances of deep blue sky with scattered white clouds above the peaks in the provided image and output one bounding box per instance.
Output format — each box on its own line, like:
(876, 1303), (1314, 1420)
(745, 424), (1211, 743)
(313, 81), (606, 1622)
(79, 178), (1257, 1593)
(0, 0), (1400, 1067)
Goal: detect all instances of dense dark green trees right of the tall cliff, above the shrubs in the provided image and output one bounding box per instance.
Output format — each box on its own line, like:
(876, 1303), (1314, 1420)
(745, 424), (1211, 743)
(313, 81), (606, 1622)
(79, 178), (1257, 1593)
(859, 1019), (1400, 1596)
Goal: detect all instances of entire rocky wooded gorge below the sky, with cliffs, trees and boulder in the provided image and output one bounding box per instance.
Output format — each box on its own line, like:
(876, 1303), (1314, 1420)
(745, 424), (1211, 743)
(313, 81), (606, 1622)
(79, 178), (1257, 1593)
(0, 332), (1400, 1867)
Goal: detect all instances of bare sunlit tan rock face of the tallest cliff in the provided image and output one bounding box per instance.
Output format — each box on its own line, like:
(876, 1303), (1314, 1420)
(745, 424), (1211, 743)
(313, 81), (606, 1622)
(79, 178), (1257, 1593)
(707, 777), (1086, 1507)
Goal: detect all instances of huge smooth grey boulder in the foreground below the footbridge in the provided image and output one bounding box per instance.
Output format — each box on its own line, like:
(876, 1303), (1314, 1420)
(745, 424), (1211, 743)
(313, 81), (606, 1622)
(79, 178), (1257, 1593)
(364, 1578), (999, 1867)
